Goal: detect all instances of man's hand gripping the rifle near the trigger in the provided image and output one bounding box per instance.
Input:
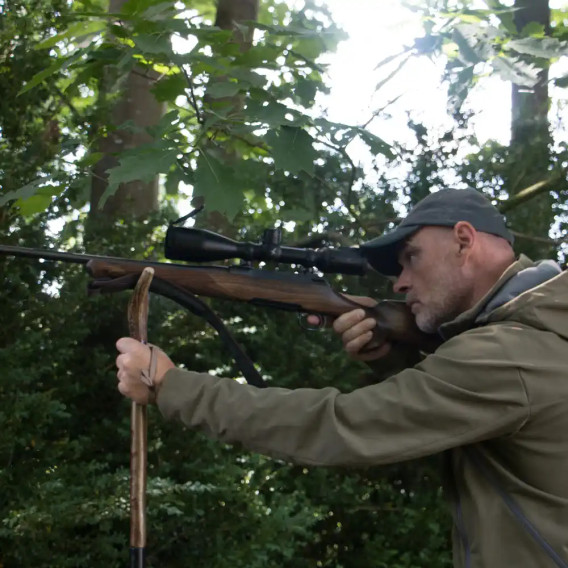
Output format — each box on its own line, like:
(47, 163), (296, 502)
(333, 306), (392, 361)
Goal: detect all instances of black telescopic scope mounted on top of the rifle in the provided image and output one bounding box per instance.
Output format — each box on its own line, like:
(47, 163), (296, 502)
(165, 225), (369, 274)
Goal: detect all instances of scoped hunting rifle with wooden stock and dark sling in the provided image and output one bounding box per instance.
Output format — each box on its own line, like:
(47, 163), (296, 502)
(0, 225), (439, 386)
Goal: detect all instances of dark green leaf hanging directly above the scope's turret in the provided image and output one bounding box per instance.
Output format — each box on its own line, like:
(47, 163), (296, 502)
(264, 126), (318, 175)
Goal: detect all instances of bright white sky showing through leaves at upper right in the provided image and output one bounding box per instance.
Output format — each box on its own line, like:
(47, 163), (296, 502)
(325, 0), (510, 143)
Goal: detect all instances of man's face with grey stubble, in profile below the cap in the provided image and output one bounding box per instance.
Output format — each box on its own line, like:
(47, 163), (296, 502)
(394, 227), (471, 333)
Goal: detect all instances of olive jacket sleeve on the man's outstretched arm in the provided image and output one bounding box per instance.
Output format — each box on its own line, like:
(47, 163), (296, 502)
(154, 326), (529, 466)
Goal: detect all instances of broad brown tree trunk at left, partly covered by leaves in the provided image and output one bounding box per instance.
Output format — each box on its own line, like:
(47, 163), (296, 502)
(90, 0), (165, 222)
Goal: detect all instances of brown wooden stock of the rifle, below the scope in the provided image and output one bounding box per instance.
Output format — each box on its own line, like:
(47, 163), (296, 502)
(87, 259), (440, 352)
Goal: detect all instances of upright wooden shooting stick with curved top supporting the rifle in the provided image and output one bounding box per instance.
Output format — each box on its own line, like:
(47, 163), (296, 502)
(128, 267), (154, 568)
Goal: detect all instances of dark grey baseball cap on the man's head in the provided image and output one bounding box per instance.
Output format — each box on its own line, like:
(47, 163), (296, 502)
(360, 189), (514, 276)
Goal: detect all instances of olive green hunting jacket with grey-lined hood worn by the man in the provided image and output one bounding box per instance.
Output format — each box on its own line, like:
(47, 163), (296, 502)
(158, 257), (568, 568)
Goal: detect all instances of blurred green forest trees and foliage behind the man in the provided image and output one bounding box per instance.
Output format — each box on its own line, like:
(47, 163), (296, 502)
(0, 0), (568, 568)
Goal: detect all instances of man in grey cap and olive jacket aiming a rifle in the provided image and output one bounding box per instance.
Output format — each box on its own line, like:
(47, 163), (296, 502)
(117, 190), (568, 568)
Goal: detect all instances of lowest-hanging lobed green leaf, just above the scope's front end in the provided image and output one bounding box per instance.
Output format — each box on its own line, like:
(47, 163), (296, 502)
(194, 150), (246, 218)
